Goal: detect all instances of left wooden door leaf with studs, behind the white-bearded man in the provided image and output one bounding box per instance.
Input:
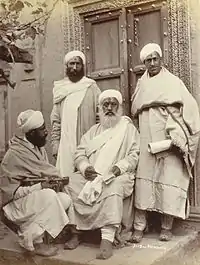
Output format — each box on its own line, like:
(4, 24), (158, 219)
(84, 9), (130, 114)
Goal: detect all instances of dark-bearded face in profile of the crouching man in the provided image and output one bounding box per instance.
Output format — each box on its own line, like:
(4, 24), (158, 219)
(26, 124), (48, 147)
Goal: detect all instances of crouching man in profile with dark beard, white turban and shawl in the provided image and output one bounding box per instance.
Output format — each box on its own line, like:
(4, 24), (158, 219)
(1, 110), (71, 256)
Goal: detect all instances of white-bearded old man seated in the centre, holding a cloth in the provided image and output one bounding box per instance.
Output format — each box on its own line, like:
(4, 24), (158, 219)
(65, 89), (139, 259)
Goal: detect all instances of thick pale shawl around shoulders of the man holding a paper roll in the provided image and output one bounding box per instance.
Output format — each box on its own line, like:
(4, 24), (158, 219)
(132, 68), (200, 171)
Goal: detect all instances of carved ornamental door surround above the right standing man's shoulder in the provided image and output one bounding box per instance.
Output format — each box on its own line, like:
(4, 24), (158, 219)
(168, 0), (191, 89)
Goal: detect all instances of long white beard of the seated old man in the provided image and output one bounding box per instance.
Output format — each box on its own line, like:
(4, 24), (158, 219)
(99, 106), (123, 129)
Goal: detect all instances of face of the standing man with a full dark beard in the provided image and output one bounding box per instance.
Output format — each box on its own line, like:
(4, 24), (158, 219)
(66, 56), (84, 82)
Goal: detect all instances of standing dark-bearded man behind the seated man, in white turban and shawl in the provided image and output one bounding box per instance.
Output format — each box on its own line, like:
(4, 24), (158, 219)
(51, 51), (100, 177)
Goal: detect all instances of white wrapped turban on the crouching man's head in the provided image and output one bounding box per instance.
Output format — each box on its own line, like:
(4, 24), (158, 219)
(17, 109), (44, 133)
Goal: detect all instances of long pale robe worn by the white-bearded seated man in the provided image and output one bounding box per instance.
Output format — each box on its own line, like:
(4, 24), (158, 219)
(68, 116), (139, 230)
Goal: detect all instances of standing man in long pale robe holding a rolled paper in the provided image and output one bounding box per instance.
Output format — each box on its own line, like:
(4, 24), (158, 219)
(132, 43), (200, 243)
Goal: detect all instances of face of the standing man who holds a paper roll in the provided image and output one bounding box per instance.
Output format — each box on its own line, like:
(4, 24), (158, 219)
(144, 52), (161, 77)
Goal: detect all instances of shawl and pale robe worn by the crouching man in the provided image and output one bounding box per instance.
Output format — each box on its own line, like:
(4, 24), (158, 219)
(1, 137), (71, 251)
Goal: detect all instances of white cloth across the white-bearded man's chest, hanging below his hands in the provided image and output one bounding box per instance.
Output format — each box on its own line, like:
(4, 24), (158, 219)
(78, 117), (130, 205)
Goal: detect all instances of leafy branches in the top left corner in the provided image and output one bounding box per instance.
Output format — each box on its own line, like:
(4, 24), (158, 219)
(0, 0), (59, 65)
